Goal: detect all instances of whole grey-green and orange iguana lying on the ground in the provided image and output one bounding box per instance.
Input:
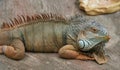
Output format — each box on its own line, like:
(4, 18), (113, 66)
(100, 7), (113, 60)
(0, 13), (109, 64)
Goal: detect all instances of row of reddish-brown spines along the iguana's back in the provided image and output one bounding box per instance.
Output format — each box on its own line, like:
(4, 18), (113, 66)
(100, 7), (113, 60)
(1, 13), (66, 29)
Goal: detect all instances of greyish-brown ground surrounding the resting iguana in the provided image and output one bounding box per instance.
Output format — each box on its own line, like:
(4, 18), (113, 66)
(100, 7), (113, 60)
(0, 0), (120, 70)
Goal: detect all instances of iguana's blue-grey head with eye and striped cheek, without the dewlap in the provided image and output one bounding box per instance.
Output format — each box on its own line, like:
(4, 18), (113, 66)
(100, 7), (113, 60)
(78, 21), (110, 51)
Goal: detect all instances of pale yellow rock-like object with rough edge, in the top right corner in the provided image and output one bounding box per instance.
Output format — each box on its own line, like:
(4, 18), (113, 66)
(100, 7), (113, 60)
(79, 0), (120, 15)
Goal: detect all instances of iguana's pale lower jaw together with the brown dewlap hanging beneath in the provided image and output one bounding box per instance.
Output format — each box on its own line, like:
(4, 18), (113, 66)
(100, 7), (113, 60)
(79, 36), (110, 64)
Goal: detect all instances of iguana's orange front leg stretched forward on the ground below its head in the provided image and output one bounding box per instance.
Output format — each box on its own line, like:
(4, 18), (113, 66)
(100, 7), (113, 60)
(59, 45), (95, 60)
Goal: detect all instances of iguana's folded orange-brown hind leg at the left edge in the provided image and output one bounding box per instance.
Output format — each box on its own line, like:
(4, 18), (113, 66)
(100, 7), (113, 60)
(0, 39), (25, 60)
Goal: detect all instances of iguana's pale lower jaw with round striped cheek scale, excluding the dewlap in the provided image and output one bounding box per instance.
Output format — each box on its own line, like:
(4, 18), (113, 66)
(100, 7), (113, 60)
(78, 36), (110, 51)
